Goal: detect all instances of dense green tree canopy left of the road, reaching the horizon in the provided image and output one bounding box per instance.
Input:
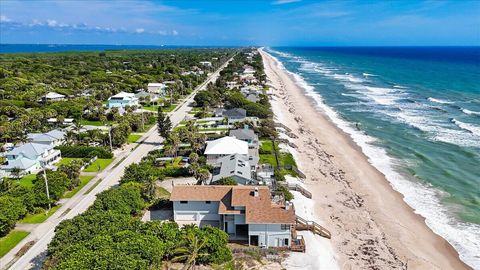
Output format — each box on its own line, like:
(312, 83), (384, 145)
(0, 49), (233, 146)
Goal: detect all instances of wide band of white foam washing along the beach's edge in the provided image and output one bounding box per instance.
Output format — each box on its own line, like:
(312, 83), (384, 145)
(268, 52), (480, 269)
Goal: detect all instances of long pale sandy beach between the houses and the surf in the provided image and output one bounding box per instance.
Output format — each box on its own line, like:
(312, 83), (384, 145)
(260, 50), (470, 269)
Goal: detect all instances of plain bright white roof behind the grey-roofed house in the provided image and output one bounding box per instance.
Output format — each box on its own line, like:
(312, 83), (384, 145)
(204, 136), (248, 155)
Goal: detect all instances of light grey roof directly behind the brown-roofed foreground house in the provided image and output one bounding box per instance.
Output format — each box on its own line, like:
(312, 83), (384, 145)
(212, 154), (252, 181)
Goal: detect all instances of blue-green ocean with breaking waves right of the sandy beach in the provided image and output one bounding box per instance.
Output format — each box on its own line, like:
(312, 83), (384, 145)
(266, 47), (480, 269)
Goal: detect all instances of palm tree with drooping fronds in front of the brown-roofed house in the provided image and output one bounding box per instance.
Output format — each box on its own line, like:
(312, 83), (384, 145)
(172, 232), (208, 270)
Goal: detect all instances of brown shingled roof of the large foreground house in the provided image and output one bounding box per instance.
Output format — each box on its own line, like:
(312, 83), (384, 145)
(170, 185), (295, 224)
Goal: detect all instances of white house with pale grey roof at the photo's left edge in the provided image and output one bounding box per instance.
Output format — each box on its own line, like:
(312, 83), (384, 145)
(2, 143), (61, 176)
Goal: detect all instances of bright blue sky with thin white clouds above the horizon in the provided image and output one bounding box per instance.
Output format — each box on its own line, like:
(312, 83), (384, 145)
(0, 0), (480, 46)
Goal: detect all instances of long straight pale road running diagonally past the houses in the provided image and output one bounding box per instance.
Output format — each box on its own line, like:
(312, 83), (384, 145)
(0, 55), (231, 270)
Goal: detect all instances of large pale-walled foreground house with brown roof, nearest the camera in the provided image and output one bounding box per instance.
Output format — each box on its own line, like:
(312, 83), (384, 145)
(170, 185), (295, 248)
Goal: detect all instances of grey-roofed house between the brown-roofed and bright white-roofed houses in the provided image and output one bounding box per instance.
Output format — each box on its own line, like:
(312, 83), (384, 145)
(212, 154), (258, 185)
